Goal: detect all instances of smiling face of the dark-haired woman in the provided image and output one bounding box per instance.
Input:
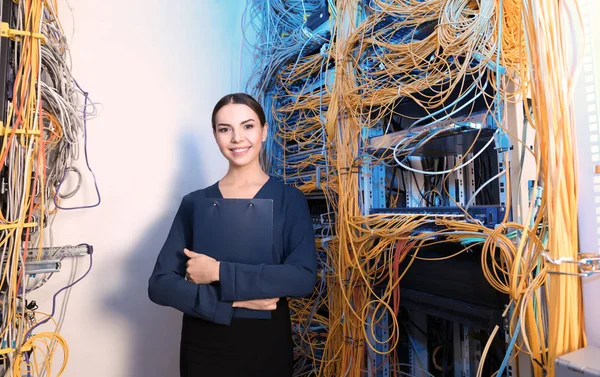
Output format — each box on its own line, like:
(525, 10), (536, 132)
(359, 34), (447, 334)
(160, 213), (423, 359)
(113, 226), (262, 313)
(215, 103), (267, 166)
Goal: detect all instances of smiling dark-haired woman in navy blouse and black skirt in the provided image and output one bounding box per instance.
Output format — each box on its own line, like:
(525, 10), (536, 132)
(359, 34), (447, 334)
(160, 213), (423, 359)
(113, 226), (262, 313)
(148, 93), (317, 377)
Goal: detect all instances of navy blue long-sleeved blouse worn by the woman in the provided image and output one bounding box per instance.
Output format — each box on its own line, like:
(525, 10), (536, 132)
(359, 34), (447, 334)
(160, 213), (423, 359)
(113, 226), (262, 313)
(148, 178), (317, 325)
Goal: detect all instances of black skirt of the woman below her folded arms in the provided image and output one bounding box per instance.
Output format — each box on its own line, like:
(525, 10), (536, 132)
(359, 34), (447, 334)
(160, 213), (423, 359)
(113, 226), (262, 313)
(179, 299), (293, 377)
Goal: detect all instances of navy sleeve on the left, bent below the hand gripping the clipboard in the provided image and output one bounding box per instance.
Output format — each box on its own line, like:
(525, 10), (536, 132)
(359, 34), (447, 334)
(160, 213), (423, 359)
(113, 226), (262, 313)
(148, 196), (233, 325)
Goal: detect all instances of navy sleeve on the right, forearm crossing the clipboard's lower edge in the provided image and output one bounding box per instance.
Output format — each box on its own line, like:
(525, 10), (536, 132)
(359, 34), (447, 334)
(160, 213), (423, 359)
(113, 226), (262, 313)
(219, 189), (317, 301)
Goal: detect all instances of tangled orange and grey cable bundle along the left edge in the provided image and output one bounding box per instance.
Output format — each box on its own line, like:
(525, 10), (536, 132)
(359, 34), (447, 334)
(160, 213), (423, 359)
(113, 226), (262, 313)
(0, 0), (100, 377)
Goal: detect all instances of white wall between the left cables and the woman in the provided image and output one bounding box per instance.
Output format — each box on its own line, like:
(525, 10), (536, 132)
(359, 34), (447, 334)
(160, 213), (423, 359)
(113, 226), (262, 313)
(28, 0), (251, 377)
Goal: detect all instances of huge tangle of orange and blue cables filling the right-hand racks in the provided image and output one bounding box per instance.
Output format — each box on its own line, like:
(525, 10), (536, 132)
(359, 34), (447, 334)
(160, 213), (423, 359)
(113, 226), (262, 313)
(245, 0), (585, 376)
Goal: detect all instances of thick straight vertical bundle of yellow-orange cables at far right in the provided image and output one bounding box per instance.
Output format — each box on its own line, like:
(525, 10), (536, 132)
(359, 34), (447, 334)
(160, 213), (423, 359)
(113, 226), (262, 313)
(522, 1), (586, 375)
